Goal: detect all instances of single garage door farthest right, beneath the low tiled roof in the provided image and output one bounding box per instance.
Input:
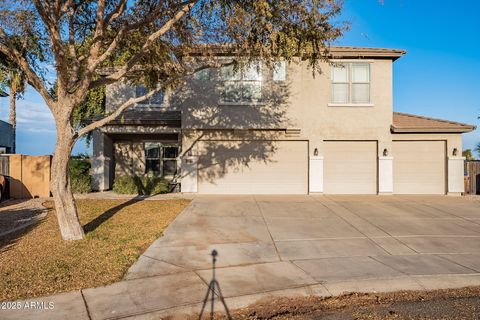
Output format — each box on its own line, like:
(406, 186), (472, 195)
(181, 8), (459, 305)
(393, 141), (445, 194)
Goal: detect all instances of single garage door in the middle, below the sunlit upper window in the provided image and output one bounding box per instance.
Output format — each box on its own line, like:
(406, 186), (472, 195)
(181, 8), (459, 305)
(324, 141), (377, 194)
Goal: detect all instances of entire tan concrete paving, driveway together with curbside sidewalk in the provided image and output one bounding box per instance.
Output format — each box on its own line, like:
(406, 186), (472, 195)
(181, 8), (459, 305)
(0, 196), (480, 319)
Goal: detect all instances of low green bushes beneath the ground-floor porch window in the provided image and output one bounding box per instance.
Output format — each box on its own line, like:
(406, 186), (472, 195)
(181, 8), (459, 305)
(113, 176), (168, 195)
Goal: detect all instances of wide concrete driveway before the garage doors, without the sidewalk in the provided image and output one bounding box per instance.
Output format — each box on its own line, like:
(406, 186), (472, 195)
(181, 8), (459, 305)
(127, 196), (480, 272)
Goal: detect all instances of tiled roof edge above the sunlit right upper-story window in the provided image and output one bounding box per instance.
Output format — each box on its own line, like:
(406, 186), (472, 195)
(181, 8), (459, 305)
(330, 46), (407, 61)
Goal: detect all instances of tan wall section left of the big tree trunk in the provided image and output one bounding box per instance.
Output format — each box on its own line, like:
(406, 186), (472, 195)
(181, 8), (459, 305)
(9, 154), (52, 199)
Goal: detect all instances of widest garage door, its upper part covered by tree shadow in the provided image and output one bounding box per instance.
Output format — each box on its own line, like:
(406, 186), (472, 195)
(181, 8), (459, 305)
(198, 141), (308, 194)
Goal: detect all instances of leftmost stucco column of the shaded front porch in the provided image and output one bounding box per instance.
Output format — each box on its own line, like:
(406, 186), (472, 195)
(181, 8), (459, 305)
(92, 130), (114, 191)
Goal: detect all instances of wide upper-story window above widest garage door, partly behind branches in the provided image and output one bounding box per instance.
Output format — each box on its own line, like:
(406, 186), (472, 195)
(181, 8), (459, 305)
(220, 62), (262, 104)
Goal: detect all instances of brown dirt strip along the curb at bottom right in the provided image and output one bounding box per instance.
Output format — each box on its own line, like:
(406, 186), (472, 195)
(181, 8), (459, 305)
(191, 287), (480, 320)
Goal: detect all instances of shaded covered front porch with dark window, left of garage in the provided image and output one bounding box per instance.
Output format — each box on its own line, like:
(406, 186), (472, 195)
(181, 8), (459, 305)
(92, 112), (181, 191)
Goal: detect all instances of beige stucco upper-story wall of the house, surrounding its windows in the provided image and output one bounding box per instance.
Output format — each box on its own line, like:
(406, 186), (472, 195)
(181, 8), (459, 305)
(107, 59), (393, 159)
